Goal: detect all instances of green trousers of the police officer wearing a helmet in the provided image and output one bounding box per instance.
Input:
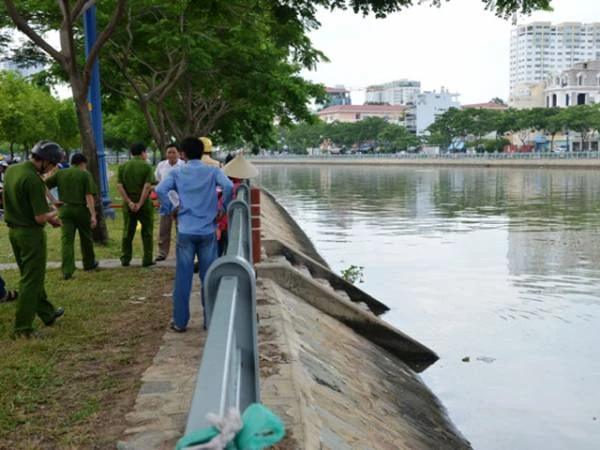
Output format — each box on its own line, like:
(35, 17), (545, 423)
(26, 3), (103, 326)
(8, 227), (55, 333)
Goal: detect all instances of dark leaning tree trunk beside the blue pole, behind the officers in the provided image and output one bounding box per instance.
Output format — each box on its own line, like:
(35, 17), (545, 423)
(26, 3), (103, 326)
(69, 86), (108, 244)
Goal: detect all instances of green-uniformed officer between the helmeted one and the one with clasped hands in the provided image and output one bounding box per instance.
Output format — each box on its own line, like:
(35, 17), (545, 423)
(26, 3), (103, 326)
(46, 153), (98, 280)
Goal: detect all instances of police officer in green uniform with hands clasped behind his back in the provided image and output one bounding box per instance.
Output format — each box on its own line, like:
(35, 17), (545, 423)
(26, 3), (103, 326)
(117, 143), (156, 267)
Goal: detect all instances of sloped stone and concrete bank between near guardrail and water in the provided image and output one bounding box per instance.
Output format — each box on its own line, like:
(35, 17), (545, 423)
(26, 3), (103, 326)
(256, 190), (471, 450)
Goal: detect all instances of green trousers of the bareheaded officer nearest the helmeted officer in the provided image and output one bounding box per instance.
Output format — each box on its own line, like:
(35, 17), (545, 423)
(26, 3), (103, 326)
(60, 204), (96, 277)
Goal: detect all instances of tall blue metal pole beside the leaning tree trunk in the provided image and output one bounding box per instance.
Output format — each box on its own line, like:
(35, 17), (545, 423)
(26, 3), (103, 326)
(83, 5), (115, 218)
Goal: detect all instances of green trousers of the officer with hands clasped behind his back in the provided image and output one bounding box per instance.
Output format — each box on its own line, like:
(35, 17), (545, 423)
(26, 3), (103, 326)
(121, 199), (154, 266)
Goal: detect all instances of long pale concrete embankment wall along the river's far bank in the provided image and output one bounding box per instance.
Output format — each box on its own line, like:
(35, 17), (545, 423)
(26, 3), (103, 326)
(252, 157), (600, 169)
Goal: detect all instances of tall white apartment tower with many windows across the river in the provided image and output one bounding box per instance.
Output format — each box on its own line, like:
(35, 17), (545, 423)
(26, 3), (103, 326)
(509, 22), (600, 107)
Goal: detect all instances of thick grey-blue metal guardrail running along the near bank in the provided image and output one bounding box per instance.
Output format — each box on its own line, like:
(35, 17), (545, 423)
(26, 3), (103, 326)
(185, 185), (260, 434)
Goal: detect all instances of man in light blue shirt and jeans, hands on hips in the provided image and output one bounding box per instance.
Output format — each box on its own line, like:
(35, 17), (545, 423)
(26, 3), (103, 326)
(156, 137), (233, 332)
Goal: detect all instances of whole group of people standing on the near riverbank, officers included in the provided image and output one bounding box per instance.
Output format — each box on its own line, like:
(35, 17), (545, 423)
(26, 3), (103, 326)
(0, 137), (258, 337)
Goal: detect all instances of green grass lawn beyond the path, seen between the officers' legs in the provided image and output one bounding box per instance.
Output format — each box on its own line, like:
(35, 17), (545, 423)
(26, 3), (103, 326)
(0, 165), (165, 264)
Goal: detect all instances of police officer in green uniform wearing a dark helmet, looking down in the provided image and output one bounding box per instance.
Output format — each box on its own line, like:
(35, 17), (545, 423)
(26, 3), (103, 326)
(4, 141), (64, 337)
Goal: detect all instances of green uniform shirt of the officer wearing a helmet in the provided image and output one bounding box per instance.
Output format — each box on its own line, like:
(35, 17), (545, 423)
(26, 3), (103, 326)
(4, 161), (50, 227)
